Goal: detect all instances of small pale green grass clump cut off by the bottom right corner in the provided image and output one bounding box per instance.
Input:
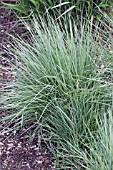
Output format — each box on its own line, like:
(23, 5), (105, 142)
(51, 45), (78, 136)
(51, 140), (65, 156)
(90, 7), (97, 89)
(89, 110), (113, 170)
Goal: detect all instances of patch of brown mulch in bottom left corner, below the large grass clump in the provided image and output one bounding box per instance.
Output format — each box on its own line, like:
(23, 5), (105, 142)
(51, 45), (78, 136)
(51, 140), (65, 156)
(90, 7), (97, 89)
(0, 131), (55, 170)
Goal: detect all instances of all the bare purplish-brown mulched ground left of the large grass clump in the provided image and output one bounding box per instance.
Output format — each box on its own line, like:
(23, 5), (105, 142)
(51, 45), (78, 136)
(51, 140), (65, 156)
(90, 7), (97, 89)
(0, 2), (55, 170)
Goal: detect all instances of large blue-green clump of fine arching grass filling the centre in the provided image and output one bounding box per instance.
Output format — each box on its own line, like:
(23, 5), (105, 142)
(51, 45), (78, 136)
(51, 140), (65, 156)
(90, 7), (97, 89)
(1, 13), (113, 169)
